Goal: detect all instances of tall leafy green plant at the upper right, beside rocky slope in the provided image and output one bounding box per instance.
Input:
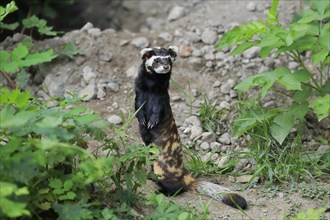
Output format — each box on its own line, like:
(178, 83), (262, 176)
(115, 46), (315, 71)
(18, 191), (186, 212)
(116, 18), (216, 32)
(217, 0), (330, 144)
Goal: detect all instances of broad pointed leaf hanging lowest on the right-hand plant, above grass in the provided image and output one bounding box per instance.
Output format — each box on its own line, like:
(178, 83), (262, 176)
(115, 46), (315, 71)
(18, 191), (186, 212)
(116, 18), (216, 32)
(270, 112), (294, 144)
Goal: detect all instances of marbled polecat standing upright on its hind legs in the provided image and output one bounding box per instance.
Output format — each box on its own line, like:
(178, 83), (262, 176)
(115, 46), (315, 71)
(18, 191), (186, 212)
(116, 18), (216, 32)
(135, 46), (247, 209)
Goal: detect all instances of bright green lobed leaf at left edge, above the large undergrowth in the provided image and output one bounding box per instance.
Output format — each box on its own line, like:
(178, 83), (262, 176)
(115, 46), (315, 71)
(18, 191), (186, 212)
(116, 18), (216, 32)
(0, 40), (57, 73)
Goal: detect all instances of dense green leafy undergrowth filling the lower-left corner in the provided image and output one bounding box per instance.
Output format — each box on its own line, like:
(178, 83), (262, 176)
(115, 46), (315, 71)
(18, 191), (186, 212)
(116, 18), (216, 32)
(0, 88), (149, 219)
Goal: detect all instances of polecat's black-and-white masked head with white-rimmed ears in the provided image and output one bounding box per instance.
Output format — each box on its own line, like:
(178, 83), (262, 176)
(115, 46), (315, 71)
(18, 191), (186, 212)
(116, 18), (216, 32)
(140, 46), (178, 74)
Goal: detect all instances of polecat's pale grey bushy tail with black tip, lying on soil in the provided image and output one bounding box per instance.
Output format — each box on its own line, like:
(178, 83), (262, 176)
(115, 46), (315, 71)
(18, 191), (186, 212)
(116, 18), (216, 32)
(196, 181), (247, 209)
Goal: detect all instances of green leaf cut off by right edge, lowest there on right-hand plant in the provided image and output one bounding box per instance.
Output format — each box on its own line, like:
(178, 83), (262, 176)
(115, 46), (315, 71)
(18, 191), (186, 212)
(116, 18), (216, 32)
(309, 95), (330, 121)
